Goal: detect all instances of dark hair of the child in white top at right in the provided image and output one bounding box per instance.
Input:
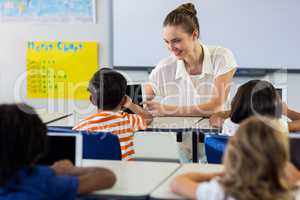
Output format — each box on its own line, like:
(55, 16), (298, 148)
(230, 80), (282, 123)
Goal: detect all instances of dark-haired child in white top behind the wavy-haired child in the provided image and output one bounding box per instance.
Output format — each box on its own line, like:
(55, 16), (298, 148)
(210, 80), (300, 135)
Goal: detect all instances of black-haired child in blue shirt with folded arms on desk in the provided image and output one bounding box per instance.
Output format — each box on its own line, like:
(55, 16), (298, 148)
(0, 104), (115, 200)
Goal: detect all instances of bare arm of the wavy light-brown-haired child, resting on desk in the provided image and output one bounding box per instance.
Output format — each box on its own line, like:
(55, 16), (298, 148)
(171, 172), (223, 199)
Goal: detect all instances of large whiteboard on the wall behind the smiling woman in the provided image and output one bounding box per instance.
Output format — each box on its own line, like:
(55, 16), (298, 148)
(113, 0), (300, 69)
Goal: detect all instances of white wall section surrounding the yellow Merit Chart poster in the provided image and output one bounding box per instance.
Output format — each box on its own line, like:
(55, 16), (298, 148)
(0, 0), (112, 115)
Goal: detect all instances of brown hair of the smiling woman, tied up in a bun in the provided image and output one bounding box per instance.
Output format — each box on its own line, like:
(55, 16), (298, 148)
(163, 3), (200, 37)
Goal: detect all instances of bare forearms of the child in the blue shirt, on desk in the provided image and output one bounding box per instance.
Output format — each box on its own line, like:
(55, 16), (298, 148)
(52, 160), (116, 194)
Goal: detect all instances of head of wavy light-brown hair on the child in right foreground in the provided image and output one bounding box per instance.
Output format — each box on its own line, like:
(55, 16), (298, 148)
(221, 117), (289, 200)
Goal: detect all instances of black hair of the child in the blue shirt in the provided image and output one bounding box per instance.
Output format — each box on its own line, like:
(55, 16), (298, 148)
(0, 104), (47, 186)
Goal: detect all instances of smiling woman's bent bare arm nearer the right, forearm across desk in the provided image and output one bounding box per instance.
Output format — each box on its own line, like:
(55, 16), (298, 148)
(145, 70), (235, 117)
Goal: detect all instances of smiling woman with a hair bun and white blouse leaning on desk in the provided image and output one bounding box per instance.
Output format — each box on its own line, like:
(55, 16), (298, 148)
(145, 3), (237, 162)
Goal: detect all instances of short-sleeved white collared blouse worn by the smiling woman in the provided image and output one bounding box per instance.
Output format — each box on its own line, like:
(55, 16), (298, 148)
(149, 45), (237, 106)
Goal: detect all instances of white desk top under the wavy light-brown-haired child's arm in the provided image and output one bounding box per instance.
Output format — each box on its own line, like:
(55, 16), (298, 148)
(150, 163), (223, 200)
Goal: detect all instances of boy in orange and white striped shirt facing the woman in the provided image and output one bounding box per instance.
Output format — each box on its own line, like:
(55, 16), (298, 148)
(73, 68), (152, 160)
